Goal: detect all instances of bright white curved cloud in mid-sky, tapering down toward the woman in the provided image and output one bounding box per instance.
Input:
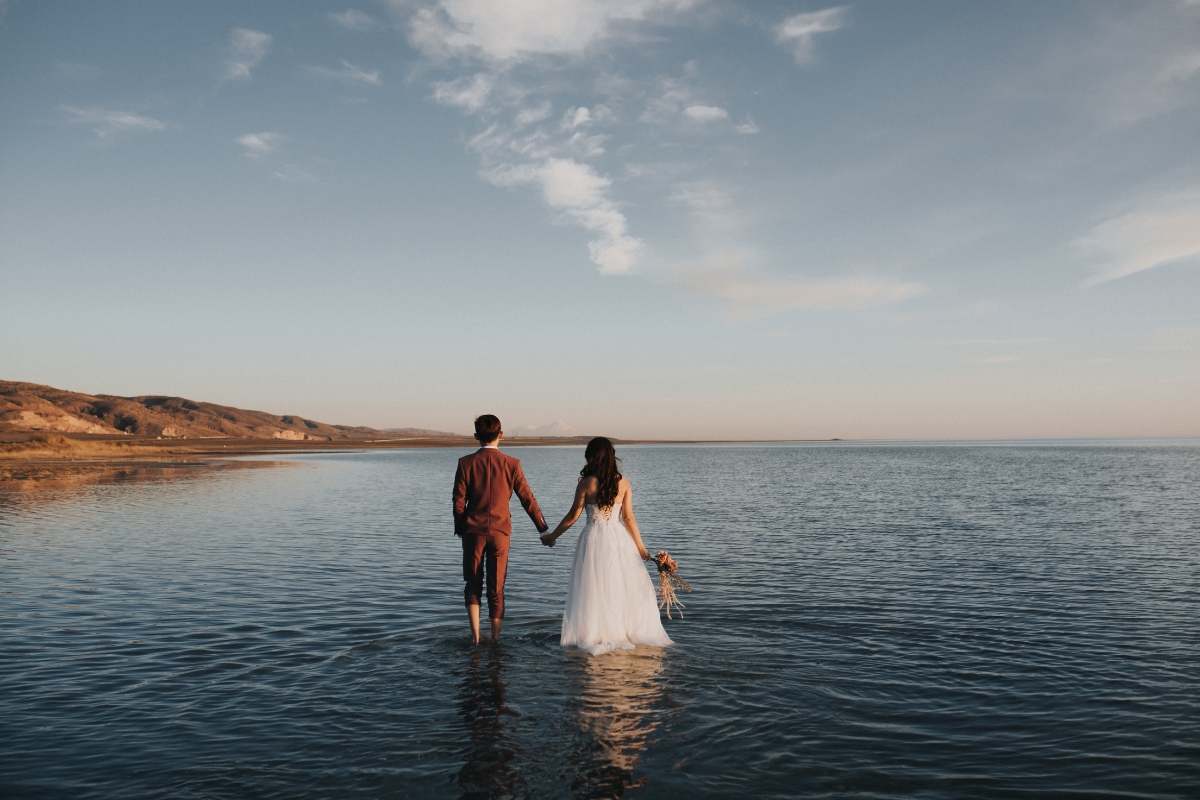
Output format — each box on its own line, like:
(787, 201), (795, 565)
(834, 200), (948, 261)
(485, 158), (642, 275)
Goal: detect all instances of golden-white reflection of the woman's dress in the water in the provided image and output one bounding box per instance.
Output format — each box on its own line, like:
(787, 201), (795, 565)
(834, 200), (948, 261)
(569, 648), (664, 798)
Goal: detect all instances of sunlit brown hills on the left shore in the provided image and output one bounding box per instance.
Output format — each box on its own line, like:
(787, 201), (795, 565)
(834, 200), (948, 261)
(0, 380), (454, 441)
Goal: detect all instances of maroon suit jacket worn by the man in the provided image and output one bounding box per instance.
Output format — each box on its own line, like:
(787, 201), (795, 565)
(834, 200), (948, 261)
(454, 447), (550, 536)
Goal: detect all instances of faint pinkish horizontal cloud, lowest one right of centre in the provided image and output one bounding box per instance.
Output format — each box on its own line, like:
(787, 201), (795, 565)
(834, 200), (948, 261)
(674, 253), (922, 318)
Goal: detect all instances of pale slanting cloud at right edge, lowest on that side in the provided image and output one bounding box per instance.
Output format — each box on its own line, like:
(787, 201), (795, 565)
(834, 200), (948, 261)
(1072, 205), (1200, 283)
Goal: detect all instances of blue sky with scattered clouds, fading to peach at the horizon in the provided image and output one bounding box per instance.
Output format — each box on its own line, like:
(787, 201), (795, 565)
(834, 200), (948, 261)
(0, 0), (1200, 438)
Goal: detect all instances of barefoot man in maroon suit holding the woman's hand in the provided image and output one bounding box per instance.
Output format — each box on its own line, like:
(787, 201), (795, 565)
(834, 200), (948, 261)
(454, 414), (550, 644)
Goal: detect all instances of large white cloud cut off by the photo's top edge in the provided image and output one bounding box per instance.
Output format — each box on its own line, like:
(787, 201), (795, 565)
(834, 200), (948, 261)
(403, 0), (692, 61)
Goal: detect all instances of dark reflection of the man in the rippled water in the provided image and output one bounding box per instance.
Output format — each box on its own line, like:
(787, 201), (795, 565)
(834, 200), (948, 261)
(458, 646), (524, 800)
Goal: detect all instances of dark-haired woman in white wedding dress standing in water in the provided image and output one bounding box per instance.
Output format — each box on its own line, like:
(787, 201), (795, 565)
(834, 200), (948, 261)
(541, 437), (673, 656)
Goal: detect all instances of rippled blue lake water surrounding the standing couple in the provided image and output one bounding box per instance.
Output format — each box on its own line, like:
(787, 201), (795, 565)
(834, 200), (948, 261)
(0, 440), (1200, 800)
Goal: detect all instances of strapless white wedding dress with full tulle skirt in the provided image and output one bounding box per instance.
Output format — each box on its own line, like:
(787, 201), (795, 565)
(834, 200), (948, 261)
(562, 504), (674, 656)
